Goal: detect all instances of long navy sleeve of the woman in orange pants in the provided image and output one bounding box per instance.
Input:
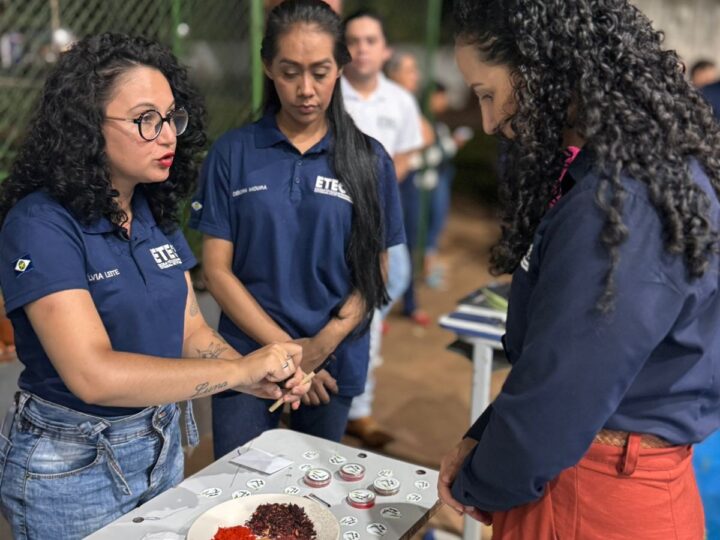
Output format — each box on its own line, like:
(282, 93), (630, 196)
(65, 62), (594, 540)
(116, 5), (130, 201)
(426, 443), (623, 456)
(452, 190), (684, 511)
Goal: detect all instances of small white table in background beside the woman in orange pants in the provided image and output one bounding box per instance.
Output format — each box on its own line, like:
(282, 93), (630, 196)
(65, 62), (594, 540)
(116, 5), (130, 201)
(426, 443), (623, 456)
(438, 305), (503, 540)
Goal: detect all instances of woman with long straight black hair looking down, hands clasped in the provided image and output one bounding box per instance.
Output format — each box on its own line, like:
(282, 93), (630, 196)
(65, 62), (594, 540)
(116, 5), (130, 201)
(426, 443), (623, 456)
(191, 0), (405, 457)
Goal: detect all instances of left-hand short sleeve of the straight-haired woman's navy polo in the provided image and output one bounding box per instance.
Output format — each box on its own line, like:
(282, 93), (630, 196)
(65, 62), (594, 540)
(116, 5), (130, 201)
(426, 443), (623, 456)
(189, 139), (232, 240)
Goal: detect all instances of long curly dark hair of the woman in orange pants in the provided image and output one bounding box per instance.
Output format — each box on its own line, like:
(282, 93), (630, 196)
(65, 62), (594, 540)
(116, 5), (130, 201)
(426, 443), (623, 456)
(455, 0), (720, 312)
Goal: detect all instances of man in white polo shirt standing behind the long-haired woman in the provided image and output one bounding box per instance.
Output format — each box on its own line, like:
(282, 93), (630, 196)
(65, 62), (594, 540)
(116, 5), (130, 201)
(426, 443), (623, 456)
(342, 10), (423, 447)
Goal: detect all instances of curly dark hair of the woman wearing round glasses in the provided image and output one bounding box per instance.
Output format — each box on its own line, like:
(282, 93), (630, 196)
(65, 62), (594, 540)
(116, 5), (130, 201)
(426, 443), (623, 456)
(0, 33), (206, 232)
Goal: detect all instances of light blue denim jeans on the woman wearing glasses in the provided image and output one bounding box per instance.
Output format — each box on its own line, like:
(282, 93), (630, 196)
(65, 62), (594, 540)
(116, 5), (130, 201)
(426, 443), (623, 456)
(0, 392), (194, 540)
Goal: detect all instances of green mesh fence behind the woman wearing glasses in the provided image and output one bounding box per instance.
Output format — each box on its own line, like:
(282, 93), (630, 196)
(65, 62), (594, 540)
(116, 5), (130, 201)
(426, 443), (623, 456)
(0, 0), (262, 178)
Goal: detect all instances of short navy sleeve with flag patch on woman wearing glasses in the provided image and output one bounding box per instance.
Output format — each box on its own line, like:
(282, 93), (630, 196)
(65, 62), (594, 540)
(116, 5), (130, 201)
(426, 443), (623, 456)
(0, 211), (88, 313)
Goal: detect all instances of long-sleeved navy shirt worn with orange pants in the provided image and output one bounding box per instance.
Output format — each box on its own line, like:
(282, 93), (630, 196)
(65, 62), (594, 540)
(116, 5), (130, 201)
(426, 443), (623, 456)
(453, 151), (720, 511)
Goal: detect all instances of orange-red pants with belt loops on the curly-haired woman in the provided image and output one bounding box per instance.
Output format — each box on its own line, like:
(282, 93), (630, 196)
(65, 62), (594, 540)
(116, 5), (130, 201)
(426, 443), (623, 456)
(493, 434), (705, 540)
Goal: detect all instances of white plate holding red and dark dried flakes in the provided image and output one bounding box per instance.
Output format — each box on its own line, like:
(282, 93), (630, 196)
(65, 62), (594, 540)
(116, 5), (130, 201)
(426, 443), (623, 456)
(187, 495), (340, 540)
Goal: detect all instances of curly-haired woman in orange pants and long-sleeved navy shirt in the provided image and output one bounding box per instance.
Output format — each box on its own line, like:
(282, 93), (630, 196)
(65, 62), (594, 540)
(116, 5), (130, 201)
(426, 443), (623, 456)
(439, 0), (720, 540)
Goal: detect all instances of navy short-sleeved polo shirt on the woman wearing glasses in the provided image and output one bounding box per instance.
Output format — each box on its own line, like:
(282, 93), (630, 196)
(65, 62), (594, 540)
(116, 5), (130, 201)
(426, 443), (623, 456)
(0, 188), (195, 416)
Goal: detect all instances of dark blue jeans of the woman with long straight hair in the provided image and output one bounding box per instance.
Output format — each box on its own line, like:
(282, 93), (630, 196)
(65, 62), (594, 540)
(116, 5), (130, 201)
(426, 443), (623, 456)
(212, 392), (352, 459)
